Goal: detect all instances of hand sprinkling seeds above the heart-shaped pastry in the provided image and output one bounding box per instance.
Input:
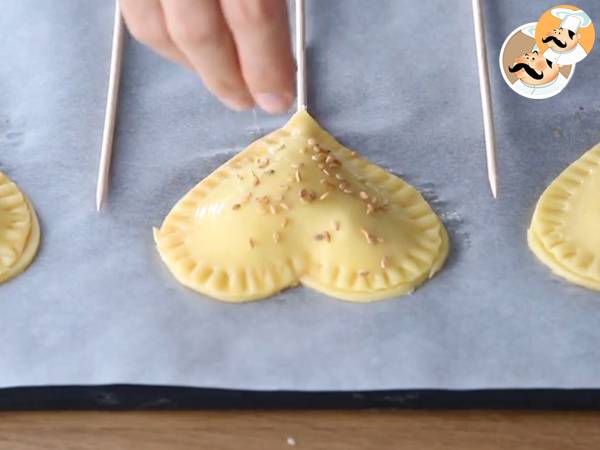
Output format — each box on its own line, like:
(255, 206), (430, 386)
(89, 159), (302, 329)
(121, 0), (295, 114)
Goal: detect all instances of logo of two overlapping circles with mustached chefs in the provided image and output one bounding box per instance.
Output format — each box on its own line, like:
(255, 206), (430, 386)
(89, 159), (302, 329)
(500, 5), (595, 99)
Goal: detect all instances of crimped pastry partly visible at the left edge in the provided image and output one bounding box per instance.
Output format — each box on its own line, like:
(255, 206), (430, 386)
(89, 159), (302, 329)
(0, 172), (40, 283)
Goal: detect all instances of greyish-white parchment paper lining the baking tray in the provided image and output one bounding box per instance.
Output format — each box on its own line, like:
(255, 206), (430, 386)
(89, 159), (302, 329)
(0, 0), (600, 390)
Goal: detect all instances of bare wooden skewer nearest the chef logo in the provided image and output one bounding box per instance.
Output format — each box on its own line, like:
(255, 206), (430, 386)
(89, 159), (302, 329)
(472, 0), (498, 198)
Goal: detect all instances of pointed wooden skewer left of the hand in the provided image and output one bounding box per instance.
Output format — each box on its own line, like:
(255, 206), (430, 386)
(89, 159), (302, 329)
(96, 0), (125, 211)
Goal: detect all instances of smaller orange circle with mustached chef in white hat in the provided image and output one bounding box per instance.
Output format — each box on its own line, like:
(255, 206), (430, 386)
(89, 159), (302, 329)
(535, 6), (595, 66)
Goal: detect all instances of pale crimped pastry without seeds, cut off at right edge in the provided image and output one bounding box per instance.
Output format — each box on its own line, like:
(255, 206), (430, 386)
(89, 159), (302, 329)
(528, 145), (600, 290)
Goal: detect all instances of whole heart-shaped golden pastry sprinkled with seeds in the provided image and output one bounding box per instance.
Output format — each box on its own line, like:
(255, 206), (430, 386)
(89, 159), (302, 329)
(154, 112), (448, 302)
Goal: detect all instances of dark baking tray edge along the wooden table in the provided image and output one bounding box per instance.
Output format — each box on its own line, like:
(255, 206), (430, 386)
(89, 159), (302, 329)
(0, 384), (600, 411)
